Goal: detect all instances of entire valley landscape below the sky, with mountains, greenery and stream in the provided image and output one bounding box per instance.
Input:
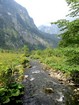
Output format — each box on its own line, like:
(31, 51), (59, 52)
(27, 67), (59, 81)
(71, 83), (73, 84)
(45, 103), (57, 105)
(0, 0), (79, 105)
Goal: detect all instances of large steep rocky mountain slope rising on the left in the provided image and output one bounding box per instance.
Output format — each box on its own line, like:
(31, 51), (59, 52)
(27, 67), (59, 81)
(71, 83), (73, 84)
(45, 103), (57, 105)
(0, 0), (59, 49)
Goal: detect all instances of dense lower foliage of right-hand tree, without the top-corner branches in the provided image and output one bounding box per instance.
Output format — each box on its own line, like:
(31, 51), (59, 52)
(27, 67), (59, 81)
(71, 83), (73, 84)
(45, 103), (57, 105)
(52, 19), (79, 47)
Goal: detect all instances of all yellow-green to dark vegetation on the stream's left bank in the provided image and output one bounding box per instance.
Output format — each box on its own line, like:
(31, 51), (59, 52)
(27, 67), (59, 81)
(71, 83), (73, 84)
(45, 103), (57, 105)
(0, 50), (28, 105)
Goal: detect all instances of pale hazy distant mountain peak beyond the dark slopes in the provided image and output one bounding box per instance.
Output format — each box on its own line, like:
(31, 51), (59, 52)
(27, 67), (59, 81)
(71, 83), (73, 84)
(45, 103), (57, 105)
(38, 24), (60, 34)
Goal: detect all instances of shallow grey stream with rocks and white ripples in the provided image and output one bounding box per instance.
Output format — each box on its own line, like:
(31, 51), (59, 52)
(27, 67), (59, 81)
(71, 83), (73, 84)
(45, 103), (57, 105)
(23, 60), (75, 105)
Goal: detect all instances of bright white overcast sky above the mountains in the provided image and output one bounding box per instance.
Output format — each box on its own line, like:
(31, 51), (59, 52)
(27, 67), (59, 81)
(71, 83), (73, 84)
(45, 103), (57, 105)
(15, 0), (69, 26)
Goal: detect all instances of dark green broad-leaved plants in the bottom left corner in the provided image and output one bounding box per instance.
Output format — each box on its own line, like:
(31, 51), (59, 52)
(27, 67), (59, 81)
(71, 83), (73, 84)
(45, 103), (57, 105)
(0, 82), (24, 104)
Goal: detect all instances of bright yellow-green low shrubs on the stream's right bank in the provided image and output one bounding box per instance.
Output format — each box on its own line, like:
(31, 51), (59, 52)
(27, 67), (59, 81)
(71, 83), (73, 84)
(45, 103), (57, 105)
(31, 47), (79, 73)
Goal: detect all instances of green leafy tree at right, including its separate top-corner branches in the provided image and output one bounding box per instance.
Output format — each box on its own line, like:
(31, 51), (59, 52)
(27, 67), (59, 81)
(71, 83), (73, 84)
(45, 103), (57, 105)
(52, 0), (79, 47)
